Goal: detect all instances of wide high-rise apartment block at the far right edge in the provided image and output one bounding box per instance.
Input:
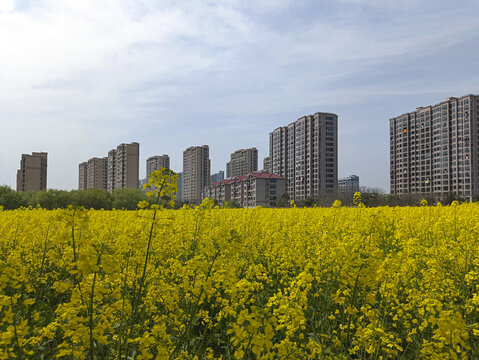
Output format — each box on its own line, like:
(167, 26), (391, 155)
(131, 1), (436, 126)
(389, 95), (479, 199)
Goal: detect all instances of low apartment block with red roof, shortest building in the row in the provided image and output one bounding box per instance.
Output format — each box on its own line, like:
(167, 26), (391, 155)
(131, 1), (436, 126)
(203, 171), (286, 207)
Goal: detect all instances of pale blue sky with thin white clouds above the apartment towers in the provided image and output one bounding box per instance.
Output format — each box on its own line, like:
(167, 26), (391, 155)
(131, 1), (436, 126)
(0, 0), (479, 192)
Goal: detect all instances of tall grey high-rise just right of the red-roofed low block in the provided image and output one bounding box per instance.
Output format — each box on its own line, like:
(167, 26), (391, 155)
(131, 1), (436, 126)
(269, 112), (338, 200)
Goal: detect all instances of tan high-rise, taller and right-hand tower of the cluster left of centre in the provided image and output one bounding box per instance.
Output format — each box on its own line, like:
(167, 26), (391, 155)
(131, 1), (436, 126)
(107, 142), (140, 192)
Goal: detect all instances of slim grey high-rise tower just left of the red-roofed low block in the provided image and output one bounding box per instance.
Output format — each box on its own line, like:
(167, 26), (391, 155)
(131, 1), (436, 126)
(182, 145), (210, 203)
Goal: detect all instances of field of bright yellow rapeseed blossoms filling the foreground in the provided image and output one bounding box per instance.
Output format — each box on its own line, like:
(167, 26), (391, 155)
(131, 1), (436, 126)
(0, 204), (479, 360)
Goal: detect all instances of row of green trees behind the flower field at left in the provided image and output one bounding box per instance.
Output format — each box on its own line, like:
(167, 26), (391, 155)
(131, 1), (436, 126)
(0, 186), (179, 210)
